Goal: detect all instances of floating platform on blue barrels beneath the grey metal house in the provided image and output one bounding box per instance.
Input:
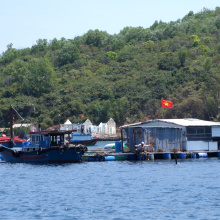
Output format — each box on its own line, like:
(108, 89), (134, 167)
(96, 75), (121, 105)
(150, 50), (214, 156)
(82, 148), (220, 162)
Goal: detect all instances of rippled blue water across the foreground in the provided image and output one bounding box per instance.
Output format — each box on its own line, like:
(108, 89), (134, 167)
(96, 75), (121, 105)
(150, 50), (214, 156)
(0, 143), (220, 220)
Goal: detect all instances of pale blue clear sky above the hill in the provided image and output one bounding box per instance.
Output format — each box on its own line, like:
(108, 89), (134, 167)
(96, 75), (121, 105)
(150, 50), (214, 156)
(0, 0), (220, 55)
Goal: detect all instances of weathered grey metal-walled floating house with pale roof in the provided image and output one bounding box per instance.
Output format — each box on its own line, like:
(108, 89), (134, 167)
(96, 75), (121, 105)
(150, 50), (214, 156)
(121, 118), (220, 152)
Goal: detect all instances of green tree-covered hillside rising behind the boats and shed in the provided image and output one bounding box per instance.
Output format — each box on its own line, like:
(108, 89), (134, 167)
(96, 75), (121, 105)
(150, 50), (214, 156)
(0, 7), (220, 128)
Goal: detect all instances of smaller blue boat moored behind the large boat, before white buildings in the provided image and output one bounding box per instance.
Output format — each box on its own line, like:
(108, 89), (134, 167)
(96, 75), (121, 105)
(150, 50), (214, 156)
(70, 125), (99, 146)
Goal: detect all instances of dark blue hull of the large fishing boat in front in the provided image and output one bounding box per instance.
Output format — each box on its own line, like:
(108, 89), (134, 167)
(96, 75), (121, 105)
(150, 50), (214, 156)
(0, 146), (84, 163)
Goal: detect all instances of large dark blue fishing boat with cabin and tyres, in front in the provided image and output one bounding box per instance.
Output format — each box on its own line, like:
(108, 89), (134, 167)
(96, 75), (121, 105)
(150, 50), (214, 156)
(0, 131), (87, 163)
